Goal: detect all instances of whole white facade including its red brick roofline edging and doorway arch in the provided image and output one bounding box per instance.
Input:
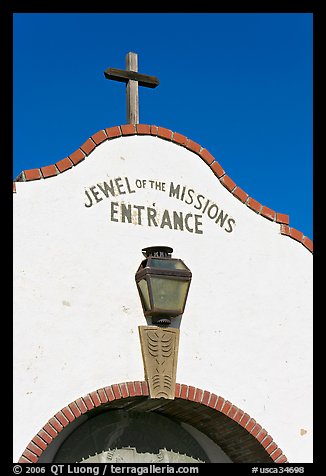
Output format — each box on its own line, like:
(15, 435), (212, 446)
(13, 124), (313, 463)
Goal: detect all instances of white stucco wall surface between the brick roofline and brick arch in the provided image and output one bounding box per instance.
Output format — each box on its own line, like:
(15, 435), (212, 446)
(14, 136), (312, 463)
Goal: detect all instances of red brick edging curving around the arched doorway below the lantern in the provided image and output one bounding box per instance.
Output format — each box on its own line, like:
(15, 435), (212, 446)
(18, 381), (288, 463)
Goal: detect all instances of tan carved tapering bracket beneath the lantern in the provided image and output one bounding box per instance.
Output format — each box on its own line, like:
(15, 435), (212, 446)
(138, 326), (180, 400)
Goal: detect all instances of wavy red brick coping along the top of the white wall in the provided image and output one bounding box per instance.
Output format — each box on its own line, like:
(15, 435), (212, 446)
(13, 124), (313, 253)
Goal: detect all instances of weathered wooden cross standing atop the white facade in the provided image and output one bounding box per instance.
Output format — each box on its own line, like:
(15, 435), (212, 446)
(104, 52), (160, 124)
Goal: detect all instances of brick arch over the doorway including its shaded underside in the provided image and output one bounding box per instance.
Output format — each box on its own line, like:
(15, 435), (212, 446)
(18, 381), (288, 463)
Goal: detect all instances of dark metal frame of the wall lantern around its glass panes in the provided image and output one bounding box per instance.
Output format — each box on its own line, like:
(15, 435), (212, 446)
(135, 246), (192, 323)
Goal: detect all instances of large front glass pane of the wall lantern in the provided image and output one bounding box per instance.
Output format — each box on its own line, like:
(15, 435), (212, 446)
(151, 276), (189, 315)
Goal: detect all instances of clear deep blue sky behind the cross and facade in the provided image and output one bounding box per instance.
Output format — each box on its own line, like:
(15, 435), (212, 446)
(13, 13), (313, 239)
